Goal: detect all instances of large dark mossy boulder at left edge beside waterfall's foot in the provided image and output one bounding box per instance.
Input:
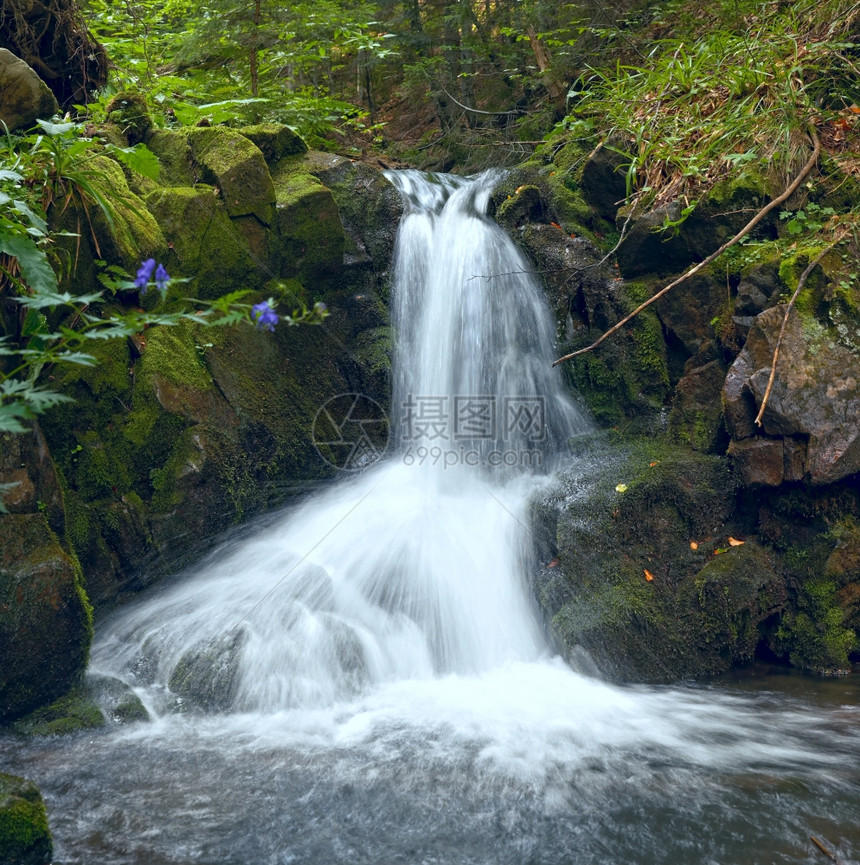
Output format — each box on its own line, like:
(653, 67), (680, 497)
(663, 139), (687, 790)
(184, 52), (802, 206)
(0, 513), (92, 721)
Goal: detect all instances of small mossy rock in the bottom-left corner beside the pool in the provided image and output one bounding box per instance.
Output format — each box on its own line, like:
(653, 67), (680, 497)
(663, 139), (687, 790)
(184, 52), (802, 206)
(0, 774), (54, 865)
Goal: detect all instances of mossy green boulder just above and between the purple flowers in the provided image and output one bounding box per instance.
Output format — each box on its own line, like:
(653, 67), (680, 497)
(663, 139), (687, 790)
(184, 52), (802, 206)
(146, 186), (262, 298)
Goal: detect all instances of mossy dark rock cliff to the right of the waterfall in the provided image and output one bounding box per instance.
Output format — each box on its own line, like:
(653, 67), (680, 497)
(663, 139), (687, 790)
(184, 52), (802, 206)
(508, 135), (860, 680)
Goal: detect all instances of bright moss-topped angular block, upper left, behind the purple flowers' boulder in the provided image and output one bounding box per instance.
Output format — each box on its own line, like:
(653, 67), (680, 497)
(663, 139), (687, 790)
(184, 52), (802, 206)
(186, 126), (275, 225)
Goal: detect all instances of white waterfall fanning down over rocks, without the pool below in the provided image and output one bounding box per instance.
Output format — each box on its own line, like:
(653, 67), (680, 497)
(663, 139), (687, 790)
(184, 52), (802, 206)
(93, 171), (588, 712)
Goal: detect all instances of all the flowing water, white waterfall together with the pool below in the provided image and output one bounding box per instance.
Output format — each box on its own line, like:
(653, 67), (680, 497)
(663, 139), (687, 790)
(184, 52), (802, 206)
(0, 172), (860, 865)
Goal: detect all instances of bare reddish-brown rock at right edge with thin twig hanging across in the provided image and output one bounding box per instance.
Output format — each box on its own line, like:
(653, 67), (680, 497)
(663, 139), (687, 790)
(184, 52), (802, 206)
(723, 305), (860, 484)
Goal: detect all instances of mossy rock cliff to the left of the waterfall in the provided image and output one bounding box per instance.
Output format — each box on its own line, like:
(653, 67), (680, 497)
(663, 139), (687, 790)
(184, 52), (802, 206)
(0, 116), (400, 720)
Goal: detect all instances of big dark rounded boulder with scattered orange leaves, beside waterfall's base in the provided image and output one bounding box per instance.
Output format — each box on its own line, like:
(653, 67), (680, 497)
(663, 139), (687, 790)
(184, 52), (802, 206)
(535, 440), (786, 681)
